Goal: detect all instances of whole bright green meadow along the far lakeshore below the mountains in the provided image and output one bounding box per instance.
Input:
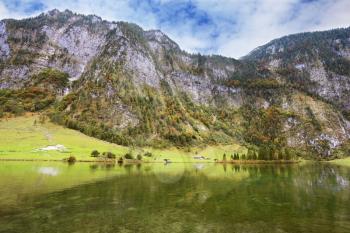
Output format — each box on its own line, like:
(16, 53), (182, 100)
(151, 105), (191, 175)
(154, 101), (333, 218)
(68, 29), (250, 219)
(0, 114), (246, 162)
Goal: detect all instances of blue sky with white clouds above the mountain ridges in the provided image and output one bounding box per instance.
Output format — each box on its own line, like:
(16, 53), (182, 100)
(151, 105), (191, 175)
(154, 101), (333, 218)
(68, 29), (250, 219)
(0, 0), (350, 58)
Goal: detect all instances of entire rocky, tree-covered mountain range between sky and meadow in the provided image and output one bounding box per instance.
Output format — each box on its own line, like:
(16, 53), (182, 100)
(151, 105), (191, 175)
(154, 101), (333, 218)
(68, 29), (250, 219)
(0, 10), (350, 157)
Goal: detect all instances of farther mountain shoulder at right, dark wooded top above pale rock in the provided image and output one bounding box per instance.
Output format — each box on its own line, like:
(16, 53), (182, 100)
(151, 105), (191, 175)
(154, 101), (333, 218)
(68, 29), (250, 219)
(244, 28), (350, 110)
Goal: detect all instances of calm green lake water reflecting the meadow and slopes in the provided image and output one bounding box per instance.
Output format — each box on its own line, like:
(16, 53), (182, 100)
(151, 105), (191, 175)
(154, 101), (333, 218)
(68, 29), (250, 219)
(0, 162), (350, 233)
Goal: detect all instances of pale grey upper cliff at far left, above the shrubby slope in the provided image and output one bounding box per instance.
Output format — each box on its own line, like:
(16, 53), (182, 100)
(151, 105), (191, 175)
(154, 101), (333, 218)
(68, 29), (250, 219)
(0, 10), (111, 89)
